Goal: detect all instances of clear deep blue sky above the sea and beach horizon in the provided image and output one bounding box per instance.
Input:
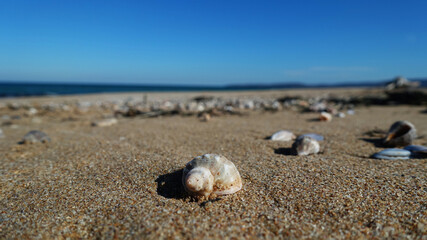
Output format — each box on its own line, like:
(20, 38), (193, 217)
(0, 0), (427, 85)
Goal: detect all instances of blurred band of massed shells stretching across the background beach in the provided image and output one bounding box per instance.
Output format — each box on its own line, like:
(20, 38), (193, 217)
(0, 95), (354, 121)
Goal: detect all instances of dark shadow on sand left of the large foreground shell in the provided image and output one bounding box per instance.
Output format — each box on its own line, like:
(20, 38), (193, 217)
(156, 169), (187, 199)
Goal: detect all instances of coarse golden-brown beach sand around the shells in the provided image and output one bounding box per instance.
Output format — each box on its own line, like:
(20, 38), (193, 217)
(0, 90), (427, 239)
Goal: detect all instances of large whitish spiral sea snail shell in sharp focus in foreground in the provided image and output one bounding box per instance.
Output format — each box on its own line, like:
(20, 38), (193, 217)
(182, 154), (242, 197)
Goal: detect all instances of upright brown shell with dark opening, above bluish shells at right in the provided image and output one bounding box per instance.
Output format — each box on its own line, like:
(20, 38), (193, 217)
(384, 121), (417, 147)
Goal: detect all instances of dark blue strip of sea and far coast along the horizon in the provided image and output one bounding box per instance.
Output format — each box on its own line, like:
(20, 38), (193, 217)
(0, 79), (427, 98)
